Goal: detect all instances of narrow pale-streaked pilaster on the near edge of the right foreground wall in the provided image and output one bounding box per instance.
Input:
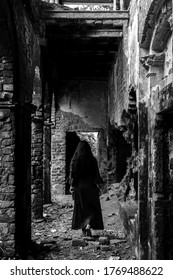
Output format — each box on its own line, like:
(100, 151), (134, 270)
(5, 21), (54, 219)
(138, 102), (148, 259)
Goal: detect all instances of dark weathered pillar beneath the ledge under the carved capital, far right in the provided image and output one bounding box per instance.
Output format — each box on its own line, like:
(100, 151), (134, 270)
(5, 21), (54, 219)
(148, 118), (164, 260)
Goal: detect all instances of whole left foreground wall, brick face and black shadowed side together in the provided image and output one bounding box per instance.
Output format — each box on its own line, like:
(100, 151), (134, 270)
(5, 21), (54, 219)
(0, 0), (39, 256)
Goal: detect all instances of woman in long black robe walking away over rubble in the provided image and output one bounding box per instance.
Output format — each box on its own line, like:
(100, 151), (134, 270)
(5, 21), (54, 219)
(70, 141), (104, 236)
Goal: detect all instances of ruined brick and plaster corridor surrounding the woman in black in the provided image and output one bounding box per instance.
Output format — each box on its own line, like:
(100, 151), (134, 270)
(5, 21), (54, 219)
(0, 0), (173, 260)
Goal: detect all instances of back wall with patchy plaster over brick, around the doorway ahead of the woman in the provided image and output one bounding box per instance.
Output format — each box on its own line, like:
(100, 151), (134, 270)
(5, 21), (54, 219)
(51, 81), (107, 194)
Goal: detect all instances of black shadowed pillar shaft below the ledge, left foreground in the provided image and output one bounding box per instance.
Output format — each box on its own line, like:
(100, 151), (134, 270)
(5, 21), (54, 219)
(15, 103), (33, 259)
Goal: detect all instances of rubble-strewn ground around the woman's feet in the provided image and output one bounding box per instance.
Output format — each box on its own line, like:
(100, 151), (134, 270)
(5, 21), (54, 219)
(29, 188), (135, 260)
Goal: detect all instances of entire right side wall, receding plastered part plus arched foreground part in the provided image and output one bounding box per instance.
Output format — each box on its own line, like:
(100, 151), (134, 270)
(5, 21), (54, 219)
(109, 0), (173, 259)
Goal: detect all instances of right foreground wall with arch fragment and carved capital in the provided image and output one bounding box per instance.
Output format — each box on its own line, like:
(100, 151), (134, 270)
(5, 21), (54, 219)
(136, 0), (172, 259)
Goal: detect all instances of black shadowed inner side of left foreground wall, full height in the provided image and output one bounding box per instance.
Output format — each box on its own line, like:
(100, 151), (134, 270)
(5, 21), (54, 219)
(12, 1), (40, 258)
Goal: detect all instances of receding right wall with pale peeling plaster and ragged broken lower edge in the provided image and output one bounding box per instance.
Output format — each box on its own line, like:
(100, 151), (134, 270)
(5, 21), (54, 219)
(108, 1), (139, 197)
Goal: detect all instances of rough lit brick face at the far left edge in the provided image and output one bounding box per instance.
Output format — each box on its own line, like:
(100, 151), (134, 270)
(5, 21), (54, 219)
(0, 3), (15, 256)
